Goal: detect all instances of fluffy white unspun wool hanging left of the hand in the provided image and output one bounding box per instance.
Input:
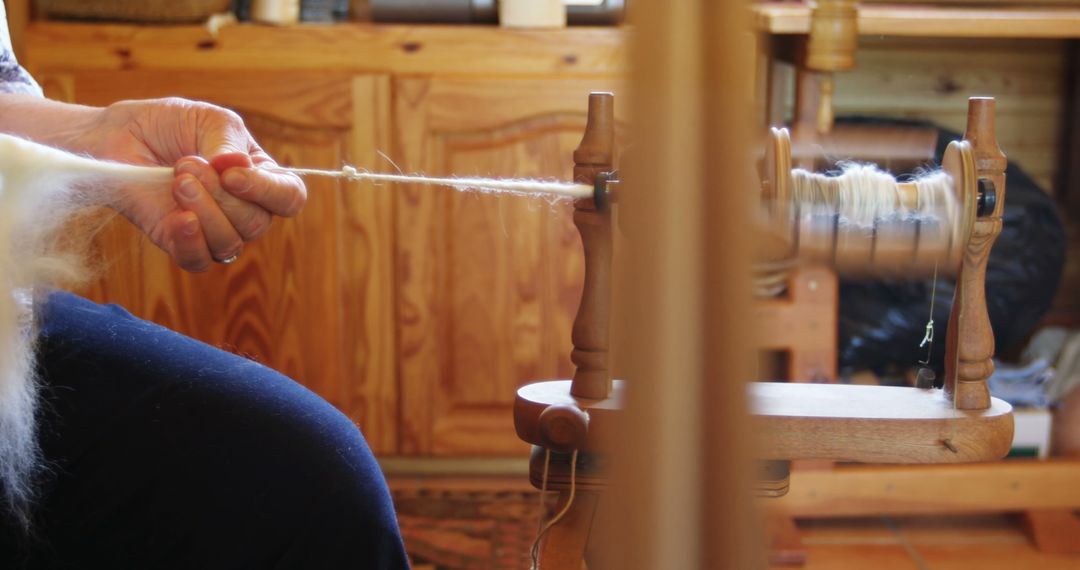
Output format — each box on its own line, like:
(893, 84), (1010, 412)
(0, 134), (173, 528)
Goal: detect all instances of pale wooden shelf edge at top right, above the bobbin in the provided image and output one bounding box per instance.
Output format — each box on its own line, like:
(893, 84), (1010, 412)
(752, 2), (1080, 39)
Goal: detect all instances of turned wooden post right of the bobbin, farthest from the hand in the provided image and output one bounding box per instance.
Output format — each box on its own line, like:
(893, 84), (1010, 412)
(945, 97), (1008, 410)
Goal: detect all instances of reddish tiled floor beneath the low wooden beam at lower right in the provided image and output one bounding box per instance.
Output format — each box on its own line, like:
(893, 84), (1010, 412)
(773, 515), (1080, 570)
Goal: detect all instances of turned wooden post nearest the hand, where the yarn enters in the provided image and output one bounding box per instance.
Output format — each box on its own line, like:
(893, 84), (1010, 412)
(570, 93), (615, 399)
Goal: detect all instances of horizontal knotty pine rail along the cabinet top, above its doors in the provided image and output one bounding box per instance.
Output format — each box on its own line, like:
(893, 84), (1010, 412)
(26, 22), (626, 77)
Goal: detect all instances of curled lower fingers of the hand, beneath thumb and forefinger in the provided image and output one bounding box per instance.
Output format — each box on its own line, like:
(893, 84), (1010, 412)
(176, 157), (270, 242)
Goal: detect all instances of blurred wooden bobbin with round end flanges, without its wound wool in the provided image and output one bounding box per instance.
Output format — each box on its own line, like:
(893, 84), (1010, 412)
(761, 128), (978, 276)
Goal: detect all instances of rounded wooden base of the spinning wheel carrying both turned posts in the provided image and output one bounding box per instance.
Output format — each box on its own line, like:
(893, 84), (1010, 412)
(514, 380), (1013, 463)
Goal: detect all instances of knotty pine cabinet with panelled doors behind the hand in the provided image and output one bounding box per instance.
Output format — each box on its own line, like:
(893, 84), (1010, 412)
(27, 24), (623, 457)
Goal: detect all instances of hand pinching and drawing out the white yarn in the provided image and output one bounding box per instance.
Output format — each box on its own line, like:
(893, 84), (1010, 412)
(83, 98), (307, 272)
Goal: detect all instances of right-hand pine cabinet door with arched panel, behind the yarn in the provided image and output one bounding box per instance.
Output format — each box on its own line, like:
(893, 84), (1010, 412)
(393, 79), (611, 456)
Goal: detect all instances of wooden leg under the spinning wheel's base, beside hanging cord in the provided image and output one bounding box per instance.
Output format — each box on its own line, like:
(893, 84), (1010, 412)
(540, 490), (599, 570)
